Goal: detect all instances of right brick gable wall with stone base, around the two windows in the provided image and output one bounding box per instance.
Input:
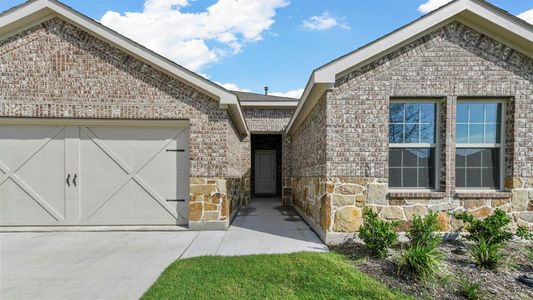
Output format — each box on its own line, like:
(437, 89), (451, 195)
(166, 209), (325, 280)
(292, 22), (533, 242)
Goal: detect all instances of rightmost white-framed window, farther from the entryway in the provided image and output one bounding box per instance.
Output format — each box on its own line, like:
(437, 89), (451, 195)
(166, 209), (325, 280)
(455, 101), (504, 189)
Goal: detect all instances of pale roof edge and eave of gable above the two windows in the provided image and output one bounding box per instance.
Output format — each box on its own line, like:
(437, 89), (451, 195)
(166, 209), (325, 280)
(285, 0), (533, 134)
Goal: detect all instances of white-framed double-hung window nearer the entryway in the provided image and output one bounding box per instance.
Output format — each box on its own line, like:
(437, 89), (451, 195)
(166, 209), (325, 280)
(389, 101), (438, 189)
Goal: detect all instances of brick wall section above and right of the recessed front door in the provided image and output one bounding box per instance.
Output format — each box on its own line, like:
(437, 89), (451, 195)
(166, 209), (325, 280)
(243, 107), (295, 205)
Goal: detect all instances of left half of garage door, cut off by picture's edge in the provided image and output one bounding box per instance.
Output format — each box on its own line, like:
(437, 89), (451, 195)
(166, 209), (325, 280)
(0, 126), (66, 225)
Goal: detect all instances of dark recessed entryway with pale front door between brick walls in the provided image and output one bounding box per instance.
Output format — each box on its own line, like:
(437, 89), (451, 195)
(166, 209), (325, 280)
(251, 134), (282, 197)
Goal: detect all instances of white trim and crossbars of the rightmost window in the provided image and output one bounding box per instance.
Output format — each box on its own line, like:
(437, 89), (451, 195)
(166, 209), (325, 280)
(454, 98), (507, 193)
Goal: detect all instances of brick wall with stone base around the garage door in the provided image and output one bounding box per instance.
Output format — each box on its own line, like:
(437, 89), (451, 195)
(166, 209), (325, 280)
(0, 18), (249, 226)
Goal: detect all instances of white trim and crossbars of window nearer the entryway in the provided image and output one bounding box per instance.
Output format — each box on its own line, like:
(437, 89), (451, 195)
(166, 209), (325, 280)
(387, 98), (443, 193)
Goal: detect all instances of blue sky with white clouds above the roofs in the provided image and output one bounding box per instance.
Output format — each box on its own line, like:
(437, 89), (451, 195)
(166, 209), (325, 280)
(0, 0), (533, 97)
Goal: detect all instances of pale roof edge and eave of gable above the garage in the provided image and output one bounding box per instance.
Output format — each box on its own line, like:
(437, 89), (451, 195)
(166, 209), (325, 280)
(0, 0), (248, 136)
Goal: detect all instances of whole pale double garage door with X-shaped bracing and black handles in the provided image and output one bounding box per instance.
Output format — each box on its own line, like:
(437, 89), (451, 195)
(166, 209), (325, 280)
(0, 125), (189, 226)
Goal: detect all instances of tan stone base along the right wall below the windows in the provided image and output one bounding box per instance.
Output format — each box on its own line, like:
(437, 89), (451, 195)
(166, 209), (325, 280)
(291, 177), (533, 243)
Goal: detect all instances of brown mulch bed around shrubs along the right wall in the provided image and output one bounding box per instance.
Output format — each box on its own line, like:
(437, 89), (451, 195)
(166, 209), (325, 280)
(333, 241), (533, 300)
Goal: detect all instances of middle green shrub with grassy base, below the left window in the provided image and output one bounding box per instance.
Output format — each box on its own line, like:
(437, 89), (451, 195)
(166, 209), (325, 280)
(398, 212), (442, 279)
